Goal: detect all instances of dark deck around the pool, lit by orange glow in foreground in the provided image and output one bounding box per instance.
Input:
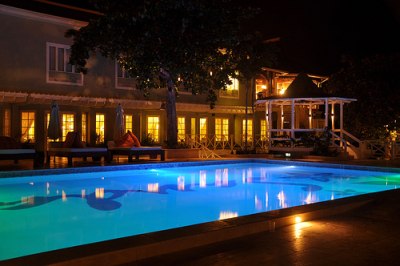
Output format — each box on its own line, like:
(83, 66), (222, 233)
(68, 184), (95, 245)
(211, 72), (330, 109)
(0, 156), (400, 265)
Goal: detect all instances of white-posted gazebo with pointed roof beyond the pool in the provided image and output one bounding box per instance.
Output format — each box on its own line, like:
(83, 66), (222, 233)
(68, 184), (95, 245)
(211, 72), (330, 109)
(256, 73), (356, 155)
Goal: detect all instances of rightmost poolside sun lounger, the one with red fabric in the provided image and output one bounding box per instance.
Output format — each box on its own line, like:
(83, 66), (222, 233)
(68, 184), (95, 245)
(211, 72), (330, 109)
(107, 141), (165, 162)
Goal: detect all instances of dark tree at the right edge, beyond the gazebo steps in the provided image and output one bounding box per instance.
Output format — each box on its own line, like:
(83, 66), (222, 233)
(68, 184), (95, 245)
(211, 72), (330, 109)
(326, 54), (400, 139)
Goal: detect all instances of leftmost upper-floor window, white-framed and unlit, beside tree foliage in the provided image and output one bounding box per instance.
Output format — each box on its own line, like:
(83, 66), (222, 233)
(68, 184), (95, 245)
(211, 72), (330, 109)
(46, 43), (83, 85)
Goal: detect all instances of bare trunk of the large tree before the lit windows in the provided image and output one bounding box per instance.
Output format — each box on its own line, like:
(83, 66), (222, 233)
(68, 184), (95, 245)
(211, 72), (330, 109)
(160, 69), (178, 148)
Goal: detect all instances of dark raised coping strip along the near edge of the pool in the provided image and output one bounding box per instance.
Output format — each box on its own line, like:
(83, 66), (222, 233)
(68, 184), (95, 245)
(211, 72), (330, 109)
(3, 190), (400, 266)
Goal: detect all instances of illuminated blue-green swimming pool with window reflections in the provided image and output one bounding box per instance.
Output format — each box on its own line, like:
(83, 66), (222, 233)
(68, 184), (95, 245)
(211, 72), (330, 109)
(0, 160), (400, 260)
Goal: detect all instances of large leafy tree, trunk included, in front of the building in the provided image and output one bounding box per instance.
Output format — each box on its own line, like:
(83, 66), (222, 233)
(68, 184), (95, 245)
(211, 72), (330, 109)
(66, 0), (276, 147)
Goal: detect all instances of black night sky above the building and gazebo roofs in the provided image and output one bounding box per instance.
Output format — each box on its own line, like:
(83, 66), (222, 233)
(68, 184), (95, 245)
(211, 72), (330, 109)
(0, 0), (400, 75)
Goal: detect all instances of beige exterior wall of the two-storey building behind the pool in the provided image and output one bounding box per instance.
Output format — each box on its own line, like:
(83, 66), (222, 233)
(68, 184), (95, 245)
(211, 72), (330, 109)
(0, 5), (256, 155)
